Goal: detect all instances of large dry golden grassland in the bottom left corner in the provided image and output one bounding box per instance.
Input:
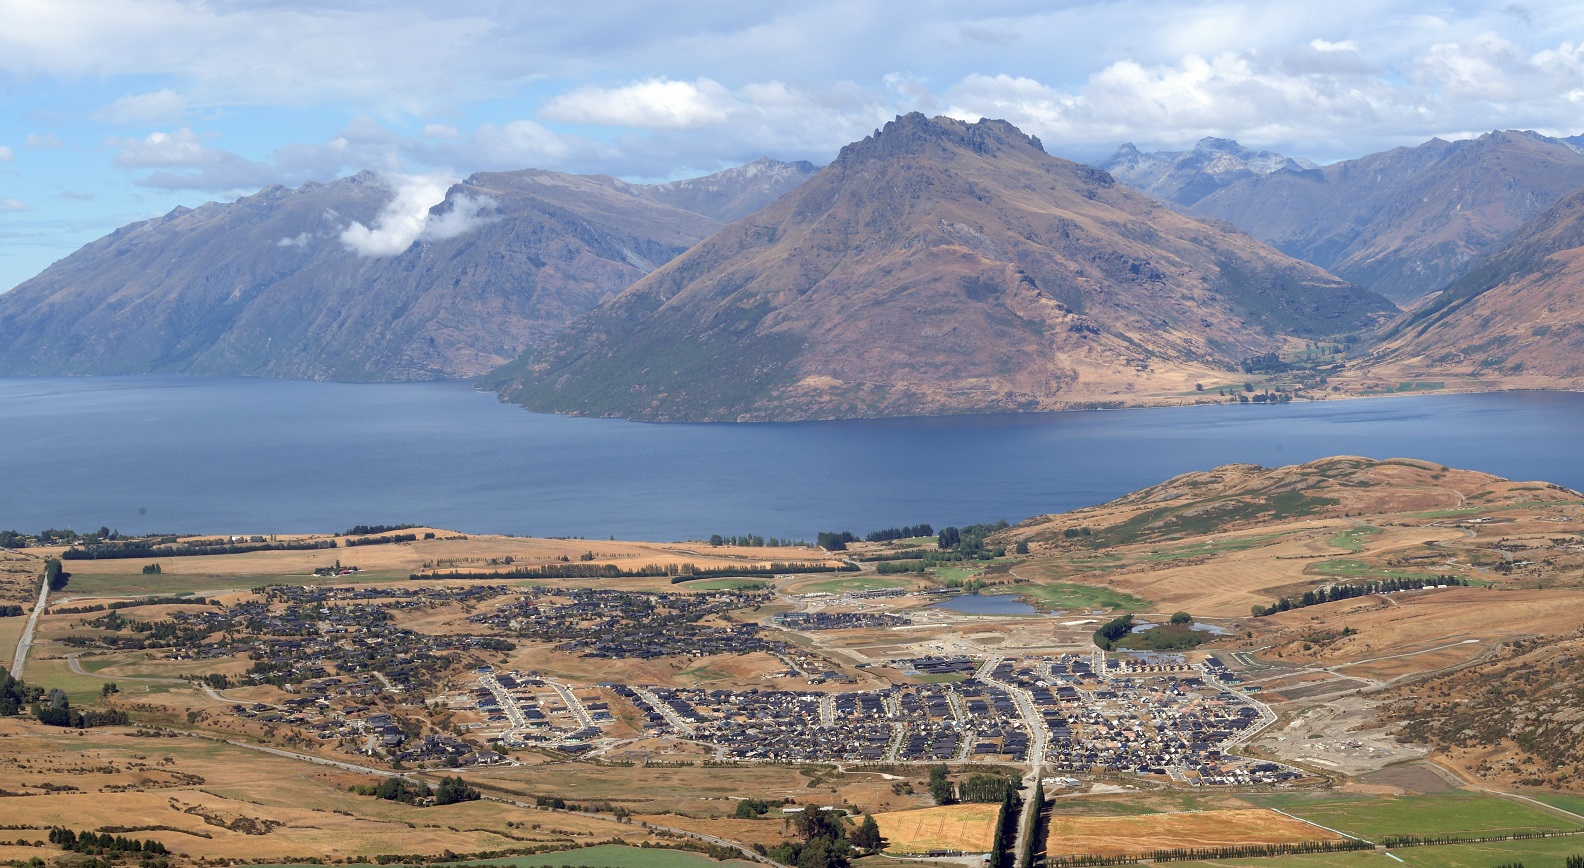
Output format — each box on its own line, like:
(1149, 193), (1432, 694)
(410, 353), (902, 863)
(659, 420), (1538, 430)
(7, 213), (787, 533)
(0, 721), (651, 862)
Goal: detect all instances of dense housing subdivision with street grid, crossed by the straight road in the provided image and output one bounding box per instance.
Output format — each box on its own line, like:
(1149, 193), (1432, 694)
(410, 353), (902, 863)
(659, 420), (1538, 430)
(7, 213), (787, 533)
(448, 653), (1300, 784)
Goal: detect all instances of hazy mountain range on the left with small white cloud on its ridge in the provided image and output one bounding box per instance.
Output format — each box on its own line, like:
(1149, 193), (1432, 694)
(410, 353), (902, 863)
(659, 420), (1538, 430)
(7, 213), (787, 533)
(0, 160), (814, 380)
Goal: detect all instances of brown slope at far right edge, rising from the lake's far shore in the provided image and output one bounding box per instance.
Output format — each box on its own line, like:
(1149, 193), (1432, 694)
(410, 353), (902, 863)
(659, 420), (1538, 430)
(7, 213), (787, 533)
(1359, 190), (1584, 388)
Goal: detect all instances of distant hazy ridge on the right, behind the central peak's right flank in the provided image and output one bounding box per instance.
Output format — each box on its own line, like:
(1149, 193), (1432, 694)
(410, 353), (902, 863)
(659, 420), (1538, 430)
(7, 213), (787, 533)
(1193, 131), (1584, 301)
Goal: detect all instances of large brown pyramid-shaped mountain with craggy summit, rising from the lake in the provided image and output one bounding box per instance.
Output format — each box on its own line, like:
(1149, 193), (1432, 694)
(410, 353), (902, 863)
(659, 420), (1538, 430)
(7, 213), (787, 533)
(486, 114), (1391, 420)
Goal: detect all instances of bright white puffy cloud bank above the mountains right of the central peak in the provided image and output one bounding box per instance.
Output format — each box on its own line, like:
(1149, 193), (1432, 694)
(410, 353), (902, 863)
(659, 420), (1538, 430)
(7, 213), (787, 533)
(946, 33), (1584, 157)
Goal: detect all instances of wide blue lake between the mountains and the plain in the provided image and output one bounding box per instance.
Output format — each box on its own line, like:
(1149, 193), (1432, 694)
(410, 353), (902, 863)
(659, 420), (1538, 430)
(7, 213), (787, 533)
(0, 375), (1584, 540)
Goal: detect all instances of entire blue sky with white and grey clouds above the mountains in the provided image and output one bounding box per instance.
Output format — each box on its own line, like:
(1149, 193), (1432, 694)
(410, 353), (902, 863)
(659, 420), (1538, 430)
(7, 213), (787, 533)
(0, 0), (1584, 288)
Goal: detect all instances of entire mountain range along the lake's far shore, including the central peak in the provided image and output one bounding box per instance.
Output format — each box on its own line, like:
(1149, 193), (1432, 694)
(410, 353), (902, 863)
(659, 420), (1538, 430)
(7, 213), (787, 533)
(9, 114), (1584, 420)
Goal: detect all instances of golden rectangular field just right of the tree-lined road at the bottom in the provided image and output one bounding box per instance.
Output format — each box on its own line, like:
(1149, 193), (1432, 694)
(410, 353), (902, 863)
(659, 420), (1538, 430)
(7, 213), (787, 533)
(1045, 808), (1342, 855)
